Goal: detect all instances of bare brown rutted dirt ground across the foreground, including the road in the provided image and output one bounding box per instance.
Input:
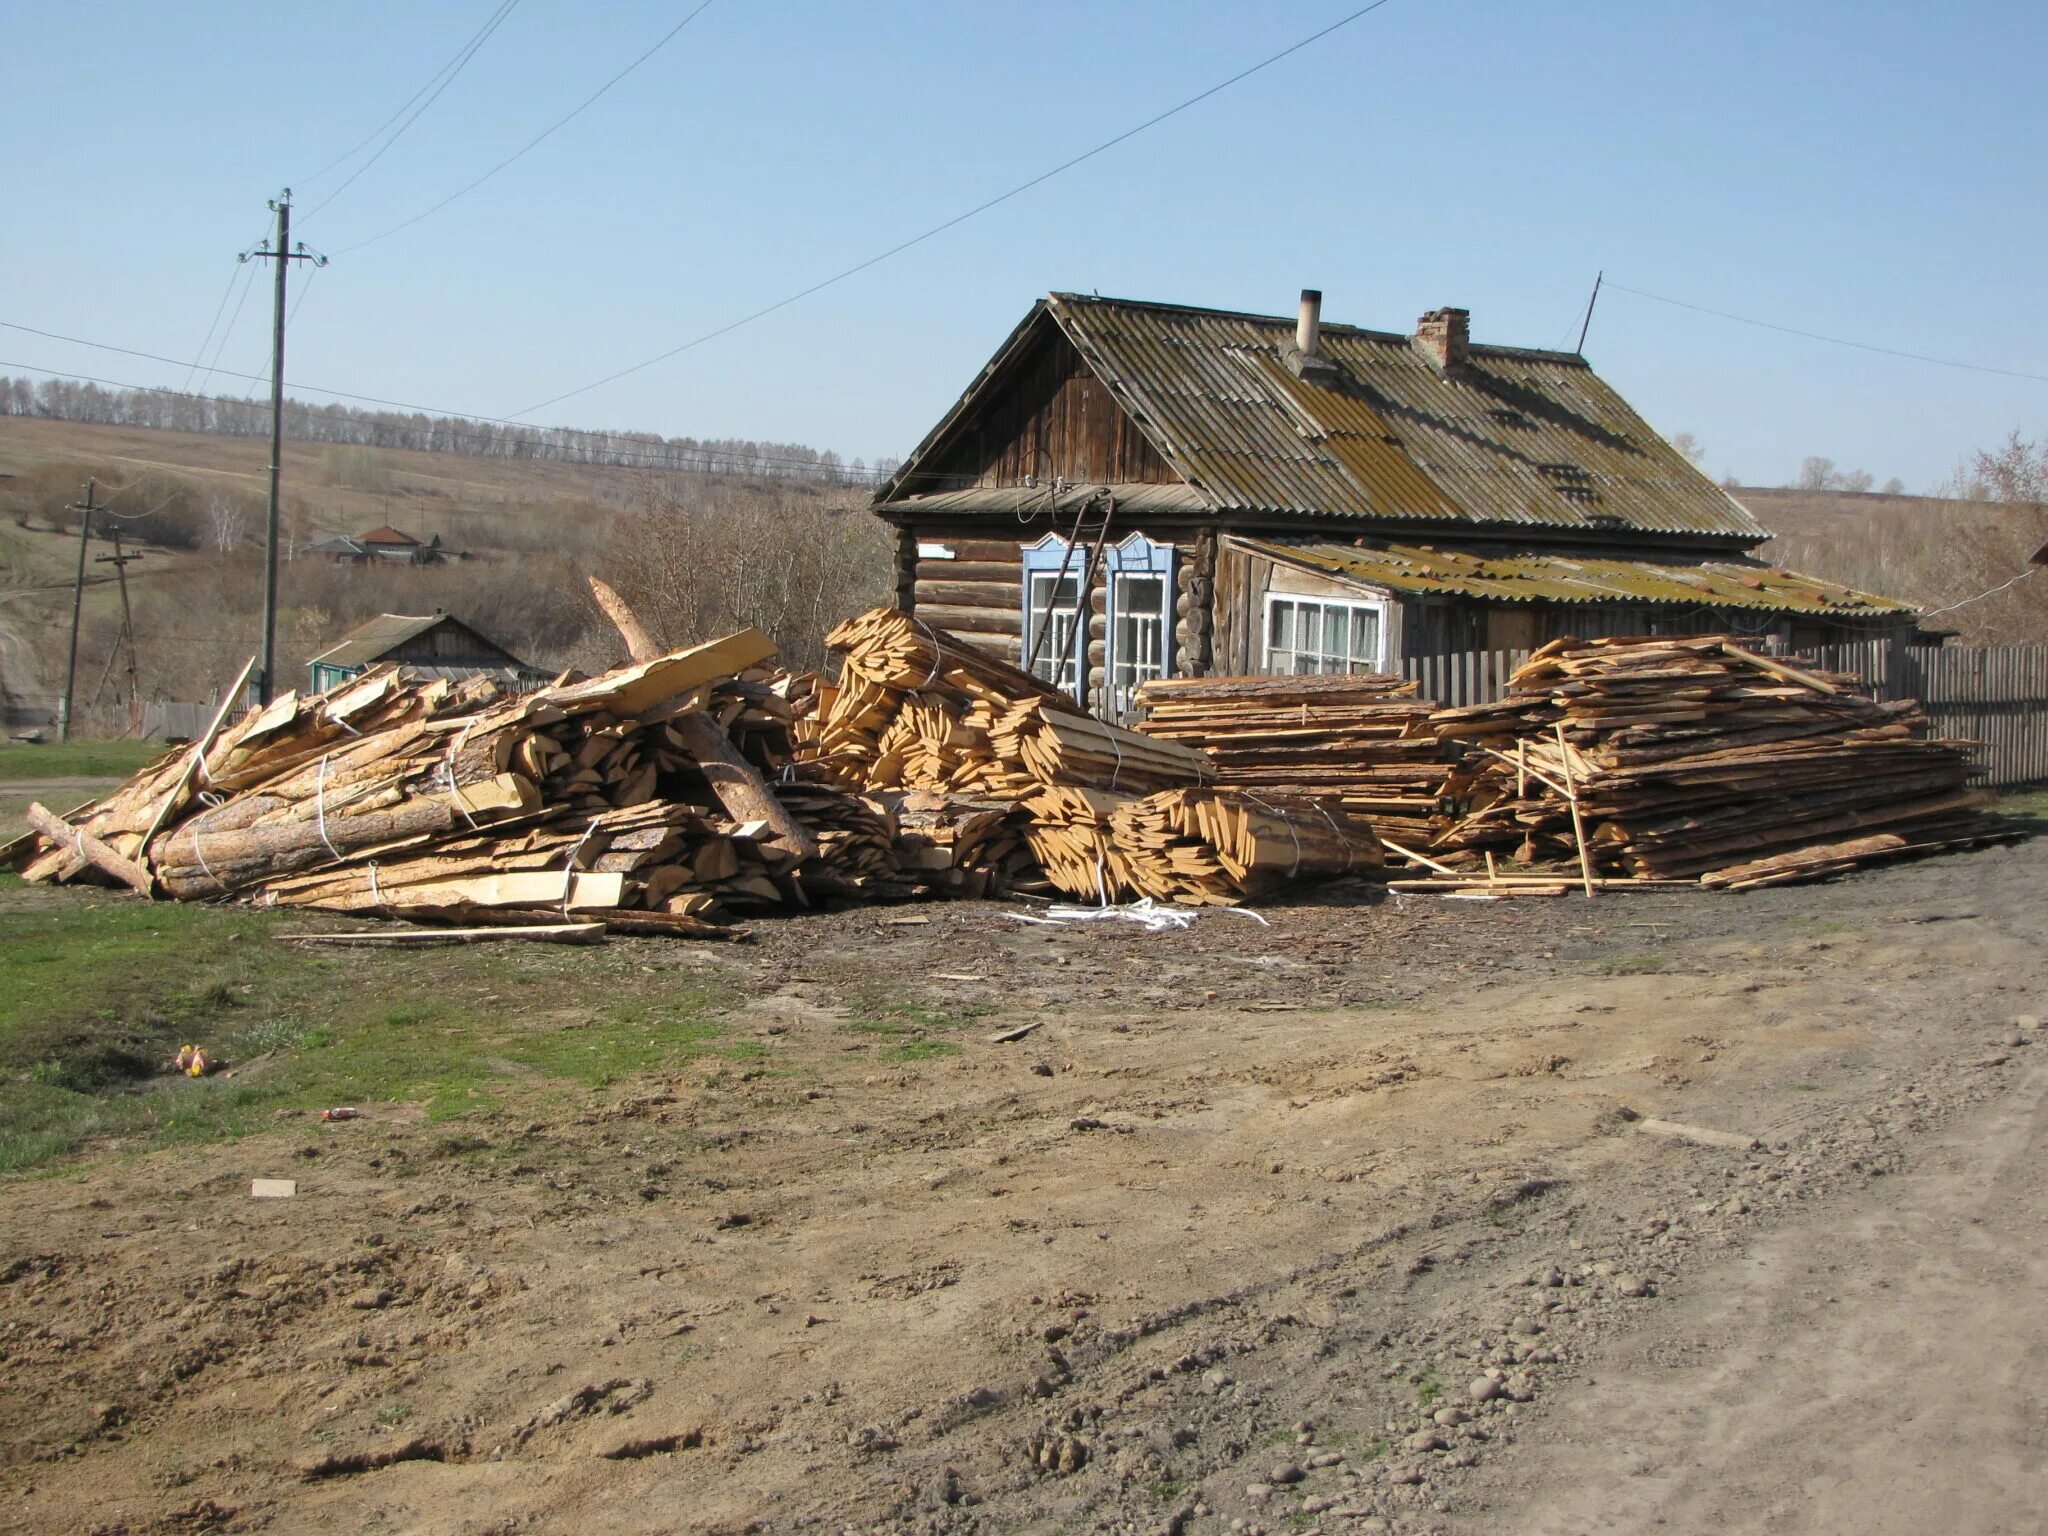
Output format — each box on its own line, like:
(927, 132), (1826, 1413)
(0, 840), (2048, 1536)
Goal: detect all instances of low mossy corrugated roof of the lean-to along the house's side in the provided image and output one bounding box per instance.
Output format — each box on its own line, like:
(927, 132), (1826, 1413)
(1229, 539), (1913, 618)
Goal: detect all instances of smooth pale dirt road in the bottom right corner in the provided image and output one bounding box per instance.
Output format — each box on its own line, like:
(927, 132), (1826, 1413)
(1456, 1059), (2048, 1536)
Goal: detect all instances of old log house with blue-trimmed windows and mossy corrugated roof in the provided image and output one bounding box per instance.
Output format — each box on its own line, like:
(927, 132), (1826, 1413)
(874, 291), (1913, 717)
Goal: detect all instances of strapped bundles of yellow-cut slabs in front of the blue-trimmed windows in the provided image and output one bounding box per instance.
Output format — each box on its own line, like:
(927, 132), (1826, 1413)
(799, 608), (1376, 905)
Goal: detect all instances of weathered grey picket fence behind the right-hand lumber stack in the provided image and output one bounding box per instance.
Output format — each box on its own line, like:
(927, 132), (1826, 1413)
(1401, 641), (2048, 786)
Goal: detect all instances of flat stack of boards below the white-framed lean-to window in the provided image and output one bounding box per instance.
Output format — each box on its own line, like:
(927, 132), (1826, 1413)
(1137, 674), (1450, 846)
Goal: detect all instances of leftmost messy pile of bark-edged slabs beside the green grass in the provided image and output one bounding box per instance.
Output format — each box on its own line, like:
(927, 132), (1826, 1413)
(16, 631), (915, 934)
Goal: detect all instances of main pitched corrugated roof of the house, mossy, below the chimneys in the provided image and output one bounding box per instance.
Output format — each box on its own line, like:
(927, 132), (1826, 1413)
(877, 293), (1767, 543)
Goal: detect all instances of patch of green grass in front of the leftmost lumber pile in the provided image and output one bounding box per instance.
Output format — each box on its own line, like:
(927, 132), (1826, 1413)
(0, 877), (760, 1174)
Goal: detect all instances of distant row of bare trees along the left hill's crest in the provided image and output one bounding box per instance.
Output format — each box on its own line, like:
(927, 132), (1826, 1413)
(0, 375), (895, 483)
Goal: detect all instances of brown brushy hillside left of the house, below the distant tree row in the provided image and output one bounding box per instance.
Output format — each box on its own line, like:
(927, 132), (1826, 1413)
(0, 416), (887, 731)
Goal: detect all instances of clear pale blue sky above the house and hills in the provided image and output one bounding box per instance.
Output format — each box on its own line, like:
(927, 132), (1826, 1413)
(0, 0), (2048, 487)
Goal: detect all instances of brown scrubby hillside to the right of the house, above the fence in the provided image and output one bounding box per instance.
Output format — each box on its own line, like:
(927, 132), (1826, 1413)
(1733, 485), (2048, 645)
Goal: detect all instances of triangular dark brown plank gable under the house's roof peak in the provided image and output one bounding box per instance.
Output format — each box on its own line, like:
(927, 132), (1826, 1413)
(903, 326), (1180, 494)
